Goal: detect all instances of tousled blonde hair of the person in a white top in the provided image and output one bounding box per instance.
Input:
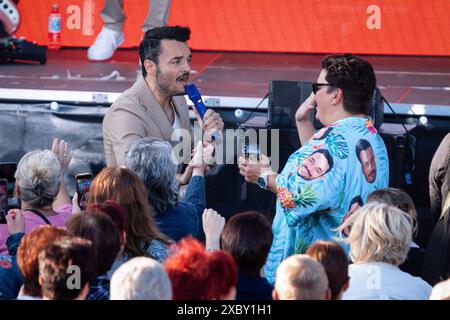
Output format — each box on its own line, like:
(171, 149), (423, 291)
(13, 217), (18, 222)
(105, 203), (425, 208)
(337, 201), (413, 266)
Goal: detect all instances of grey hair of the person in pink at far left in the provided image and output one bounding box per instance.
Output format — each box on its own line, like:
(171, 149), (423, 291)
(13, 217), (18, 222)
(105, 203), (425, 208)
(15, 150), (61, 207)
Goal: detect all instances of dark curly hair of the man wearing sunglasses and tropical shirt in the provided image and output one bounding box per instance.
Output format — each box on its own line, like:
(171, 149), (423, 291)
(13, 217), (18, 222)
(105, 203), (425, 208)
(322, 53), (377, 115)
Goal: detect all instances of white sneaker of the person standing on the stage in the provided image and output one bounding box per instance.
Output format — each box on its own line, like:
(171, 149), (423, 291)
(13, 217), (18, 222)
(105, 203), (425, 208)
(88, 27), (125, 61)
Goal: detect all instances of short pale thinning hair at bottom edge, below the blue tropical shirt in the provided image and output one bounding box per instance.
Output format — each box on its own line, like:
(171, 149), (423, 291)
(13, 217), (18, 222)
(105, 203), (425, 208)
(275, 254), (328, 300)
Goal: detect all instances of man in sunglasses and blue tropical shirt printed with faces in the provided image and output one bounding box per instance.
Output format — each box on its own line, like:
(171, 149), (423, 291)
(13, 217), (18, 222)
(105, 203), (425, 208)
(239, 54), (389, 283)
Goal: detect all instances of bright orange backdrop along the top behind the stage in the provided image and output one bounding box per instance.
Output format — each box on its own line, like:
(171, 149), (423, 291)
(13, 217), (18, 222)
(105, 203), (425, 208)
(17, 0), (450, 56)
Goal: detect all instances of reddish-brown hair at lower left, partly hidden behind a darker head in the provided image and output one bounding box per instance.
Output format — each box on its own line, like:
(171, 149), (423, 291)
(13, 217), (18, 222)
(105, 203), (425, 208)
(17, 225), (70, 297)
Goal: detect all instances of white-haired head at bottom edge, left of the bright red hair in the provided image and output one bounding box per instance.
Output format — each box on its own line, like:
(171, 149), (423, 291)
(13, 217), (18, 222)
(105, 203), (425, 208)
(110, 257), (172, 300)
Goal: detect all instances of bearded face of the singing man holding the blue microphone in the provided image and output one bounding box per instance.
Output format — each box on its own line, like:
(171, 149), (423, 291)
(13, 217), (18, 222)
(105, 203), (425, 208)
(156, 39), (191, 96)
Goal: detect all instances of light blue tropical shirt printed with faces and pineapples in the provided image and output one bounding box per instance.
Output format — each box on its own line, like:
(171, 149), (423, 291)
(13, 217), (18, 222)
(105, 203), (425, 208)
(264, 117), (389, 283)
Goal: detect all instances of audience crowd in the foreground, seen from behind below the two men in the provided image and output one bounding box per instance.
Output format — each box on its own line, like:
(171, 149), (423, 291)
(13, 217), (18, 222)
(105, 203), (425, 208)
(0, 132), (450, 300)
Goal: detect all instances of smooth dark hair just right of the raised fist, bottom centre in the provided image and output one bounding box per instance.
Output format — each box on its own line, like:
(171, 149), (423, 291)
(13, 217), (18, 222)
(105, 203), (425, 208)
(220, 211), (273, 274)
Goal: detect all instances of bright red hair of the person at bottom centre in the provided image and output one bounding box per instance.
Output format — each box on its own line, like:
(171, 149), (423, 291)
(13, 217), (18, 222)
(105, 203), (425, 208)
(164, 237), (237, 300)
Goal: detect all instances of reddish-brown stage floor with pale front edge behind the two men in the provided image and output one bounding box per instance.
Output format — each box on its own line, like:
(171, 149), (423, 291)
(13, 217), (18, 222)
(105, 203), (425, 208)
(0, 49), (450, 117)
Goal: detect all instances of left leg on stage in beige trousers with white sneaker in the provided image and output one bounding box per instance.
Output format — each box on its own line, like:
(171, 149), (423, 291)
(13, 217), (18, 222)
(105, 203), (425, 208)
(87, 0), (126, 61)
